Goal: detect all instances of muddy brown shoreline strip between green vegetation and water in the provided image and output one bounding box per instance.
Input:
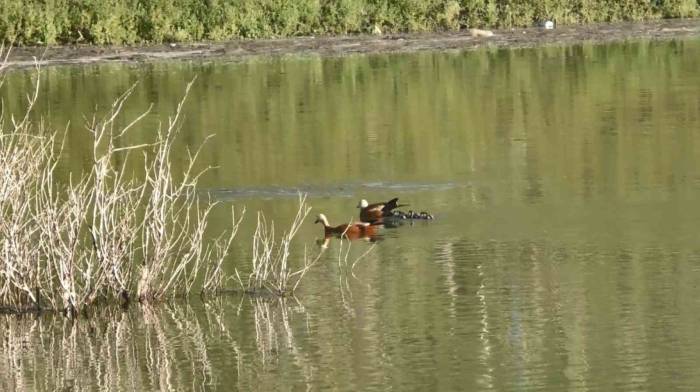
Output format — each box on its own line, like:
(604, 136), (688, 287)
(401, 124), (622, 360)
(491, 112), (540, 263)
(6, 19), (700, 68)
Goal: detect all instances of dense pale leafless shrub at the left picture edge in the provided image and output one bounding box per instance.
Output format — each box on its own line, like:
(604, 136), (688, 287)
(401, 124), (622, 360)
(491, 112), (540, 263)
(0, 54), (55, 308)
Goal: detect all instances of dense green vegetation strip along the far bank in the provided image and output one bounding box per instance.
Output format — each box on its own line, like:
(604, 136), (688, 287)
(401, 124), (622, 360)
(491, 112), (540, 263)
(0, 0), (700, 45)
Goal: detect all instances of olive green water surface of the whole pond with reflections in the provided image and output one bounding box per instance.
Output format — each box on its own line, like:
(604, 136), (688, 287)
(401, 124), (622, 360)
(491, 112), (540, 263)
(0, 40), (700, 391)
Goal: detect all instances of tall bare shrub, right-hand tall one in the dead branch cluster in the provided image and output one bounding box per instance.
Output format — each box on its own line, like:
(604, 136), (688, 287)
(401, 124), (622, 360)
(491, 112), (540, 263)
(136, 82), (223, 301)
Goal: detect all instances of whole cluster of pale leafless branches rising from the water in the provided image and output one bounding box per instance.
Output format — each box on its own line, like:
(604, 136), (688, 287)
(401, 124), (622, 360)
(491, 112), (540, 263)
(0, 48), (318, 314)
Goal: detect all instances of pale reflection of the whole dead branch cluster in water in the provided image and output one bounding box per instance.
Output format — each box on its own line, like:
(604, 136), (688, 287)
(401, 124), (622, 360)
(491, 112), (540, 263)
(0, 298), (313, 392)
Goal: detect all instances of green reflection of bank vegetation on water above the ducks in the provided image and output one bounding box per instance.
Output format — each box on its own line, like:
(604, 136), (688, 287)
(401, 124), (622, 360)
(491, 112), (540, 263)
(5, 40), (700, 201)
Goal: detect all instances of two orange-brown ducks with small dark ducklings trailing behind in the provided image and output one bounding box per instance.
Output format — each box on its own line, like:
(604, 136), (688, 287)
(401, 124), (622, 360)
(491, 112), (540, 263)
(314, 197), (433, 239)
